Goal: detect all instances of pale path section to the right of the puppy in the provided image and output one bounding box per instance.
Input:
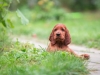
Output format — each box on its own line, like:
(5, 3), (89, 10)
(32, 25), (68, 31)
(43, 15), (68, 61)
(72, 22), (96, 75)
(70, 45), (100, 75)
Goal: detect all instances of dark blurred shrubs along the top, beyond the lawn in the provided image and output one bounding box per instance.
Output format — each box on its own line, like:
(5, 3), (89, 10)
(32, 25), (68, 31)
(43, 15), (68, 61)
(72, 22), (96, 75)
(10, 0), (100, 12)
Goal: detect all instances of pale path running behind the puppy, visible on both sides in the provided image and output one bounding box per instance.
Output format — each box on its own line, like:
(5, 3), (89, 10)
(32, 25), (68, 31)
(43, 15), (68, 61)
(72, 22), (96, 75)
(13, 37), (100, 75)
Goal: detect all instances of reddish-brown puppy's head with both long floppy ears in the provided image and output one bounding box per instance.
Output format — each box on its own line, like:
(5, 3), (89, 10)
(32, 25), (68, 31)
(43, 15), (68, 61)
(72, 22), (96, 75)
(49, 24), (71, 45)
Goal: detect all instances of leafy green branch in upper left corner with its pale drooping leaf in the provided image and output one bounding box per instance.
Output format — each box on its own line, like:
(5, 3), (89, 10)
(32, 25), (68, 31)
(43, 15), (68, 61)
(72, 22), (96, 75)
(0, 0), (29, 28)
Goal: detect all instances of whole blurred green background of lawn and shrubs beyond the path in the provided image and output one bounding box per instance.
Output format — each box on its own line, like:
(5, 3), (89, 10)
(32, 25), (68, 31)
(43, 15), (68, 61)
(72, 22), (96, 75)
(0, 0), (100, 49)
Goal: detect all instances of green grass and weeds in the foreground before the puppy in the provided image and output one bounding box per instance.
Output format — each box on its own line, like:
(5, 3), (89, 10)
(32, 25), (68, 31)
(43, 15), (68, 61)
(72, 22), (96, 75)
(0, 41), (89, 75)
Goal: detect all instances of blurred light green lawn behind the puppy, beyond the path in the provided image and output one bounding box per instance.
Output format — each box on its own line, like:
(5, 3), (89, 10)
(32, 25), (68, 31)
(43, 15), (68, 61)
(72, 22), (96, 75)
(8, 10), (100, 49)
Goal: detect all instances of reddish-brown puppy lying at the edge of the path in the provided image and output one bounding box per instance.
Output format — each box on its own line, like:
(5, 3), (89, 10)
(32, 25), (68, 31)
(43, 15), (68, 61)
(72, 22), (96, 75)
(47, 24), (89, 59)
